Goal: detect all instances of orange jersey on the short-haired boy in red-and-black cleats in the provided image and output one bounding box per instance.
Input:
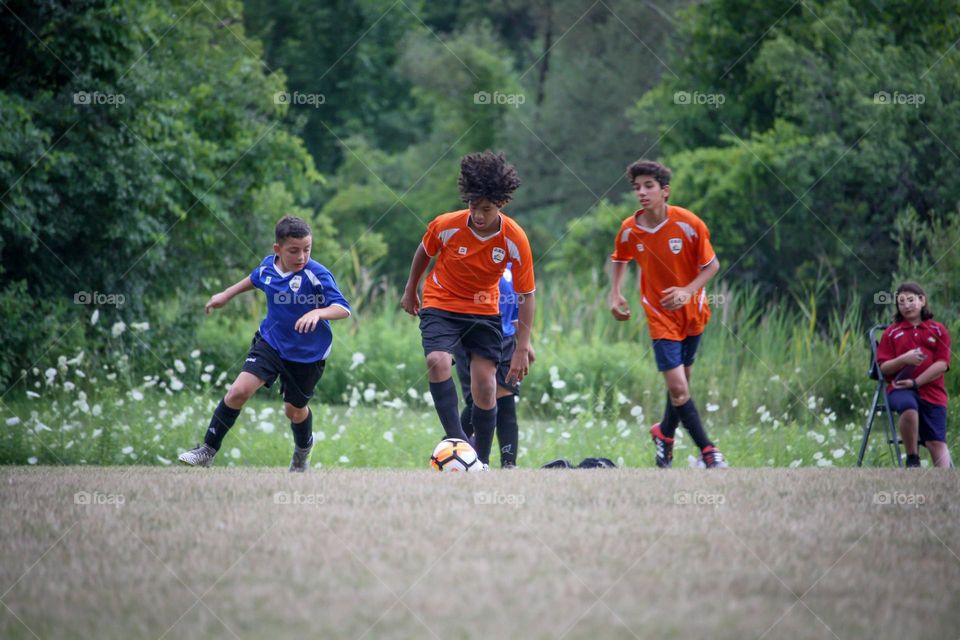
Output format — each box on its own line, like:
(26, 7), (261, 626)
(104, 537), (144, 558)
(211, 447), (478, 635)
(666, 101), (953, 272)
(610, 206), (717, 340)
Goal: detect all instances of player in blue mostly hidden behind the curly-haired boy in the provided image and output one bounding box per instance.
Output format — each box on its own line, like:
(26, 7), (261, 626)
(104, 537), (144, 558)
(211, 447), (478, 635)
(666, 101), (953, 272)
(453, 263), (536, 469)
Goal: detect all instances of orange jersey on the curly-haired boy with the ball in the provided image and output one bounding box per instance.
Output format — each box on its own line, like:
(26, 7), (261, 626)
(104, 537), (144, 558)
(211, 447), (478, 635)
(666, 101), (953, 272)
(423, 209), (536, 316)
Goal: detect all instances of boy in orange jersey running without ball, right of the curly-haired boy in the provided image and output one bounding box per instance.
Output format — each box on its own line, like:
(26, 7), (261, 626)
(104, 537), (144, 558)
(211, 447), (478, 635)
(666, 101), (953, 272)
(610, 160), (727, 469)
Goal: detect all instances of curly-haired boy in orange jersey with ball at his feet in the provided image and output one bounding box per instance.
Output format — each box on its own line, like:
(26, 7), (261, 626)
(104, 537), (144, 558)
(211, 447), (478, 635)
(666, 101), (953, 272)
(400, 151), (536, 467)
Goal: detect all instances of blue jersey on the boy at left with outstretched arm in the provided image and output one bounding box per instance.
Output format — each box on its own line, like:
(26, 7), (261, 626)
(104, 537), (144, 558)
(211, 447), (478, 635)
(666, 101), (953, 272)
(250, 255), (351, 362)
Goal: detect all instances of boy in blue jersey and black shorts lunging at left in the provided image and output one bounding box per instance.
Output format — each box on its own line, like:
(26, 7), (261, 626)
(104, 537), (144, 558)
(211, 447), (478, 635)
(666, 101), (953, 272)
(179, 216), (350, 472)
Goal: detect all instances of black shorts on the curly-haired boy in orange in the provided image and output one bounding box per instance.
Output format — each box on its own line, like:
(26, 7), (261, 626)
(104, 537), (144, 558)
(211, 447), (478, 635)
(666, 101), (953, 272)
(420, 309), (503, 362)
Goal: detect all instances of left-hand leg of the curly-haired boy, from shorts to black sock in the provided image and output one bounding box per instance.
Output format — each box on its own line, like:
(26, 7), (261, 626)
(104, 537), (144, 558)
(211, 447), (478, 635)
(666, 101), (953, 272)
(420, 309), (467, 440)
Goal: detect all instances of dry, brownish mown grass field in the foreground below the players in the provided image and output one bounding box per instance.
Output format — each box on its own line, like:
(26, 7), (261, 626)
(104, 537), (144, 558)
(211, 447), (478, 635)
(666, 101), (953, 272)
(0, 466), (960, 639)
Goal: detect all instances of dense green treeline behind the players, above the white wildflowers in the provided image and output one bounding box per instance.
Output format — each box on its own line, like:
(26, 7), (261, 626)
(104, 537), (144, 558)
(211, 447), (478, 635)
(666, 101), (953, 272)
(0, 0), (960, 388)
